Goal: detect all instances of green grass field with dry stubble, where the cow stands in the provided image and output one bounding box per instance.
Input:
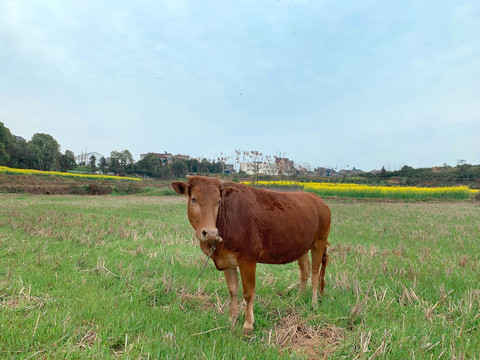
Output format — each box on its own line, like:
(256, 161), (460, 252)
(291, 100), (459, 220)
(0, 195), (480, 359)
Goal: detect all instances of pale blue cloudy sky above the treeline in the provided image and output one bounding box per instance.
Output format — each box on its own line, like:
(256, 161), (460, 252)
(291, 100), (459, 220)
(0, 0), (480, 170)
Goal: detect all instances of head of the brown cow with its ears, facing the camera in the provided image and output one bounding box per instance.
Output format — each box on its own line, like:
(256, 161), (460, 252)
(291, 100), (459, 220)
(172, 176), (239, 243)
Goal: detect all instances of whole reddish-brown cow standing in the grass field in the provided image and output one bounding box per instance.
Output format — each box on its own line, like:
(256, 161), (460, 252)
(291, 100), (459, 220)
(172, 176), (331, 331)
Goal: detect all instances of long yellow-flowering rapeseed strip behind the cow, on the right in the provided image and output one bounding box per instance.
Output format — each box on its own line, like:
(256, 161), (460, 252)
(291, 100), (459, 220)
(246, 181), (478, 200)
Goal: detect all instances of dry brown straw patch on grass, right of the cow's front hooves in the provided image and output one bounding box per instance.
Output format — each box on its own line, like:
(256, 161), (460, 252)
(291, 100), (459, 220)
(275, 314), (344, 359)
